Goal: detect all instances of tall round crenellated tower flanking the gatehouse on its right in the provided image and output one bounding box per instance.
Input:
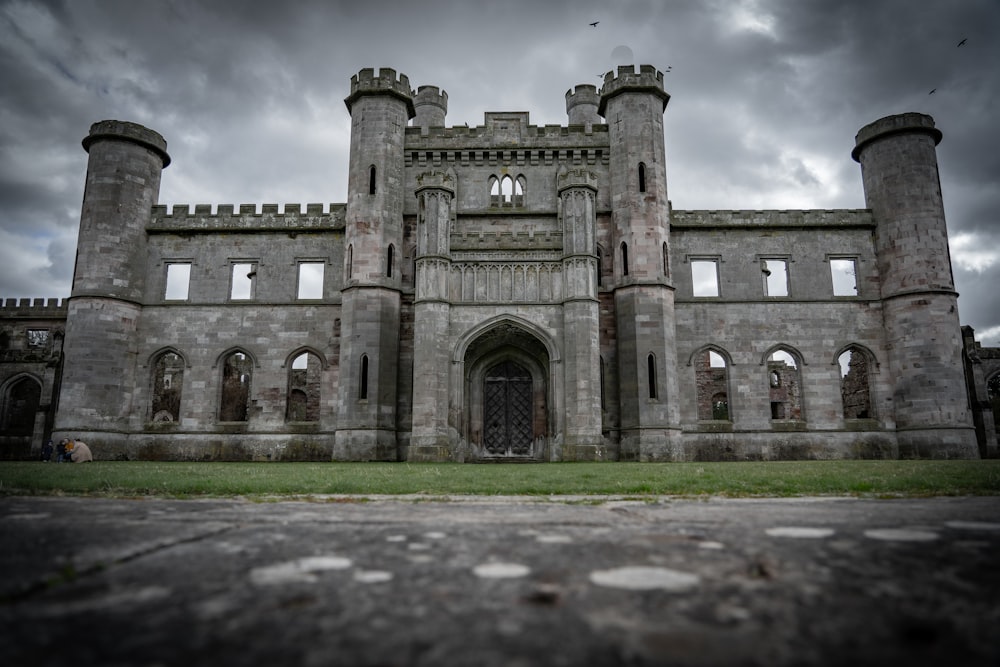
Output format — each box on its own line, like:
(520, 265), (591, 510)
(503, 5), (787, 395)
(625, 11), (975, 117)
(598, 65), (683, 461)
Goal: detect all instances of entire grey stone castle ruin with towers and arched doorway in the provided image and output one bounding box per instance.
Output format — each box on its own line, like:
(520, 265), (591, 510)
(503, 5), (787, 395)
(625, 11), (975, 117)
(0, 65), (1000, 461)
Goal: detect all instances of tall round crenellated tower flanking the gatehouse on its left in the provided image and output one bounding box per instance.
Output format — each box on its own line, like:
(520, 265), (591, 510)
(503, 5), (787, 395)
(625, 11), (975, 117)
(333, 68), (415, 461)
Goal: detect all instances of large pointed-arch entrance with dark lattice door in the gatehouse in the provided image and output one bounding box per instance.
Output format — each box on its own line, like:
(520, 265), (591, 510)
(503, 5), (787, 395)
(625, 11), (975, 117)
(461, 319), (552, 460)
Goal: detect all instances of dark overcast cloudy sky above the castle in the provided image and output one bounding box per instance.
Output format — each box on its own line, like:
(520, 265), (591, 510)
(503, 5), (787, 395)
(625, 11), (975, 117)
(0, 0), (1000, 345)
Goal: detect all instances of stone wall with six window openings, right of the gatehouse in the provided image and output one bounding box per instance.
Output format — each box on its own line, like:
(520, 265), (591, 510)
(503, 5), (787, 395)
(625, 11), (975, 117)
(670, 209), (895, 458)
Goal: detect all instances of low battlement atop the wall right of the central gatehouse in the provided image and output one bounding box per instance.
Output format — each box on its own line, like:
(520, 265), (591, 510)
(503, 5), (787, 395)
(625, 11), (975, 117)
(670, 208), (875, 229)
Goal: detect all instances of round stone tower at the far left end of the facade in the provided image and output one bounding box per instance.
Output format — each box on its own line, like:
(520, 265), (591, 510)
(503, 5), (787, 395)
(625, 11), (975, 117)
(53, 120), (170, 458)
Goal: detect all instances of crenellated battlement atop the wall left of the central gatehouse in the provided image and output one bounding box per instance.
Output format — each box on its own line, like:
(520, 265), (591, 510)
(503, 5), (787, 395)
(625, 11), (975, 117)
(146, 204), (345, 232)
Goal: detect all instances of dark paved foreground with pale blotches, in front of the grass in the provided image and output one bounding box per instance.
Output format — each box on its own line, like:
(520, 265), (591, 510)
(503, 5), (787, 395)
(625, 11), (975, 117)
(0, 497), (1000, 667)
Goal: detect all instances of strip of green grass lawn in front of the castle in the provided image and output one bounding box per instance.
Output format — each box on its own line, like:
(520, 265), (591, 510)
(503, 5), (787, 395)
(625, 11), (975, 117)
(0, 460), (1000, 498)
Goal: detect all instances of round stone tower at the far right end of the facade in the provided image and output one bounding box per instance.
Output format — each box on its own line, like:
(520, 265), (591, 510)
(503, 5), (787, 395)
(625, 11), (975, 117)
(851, 113), (978, 458)
